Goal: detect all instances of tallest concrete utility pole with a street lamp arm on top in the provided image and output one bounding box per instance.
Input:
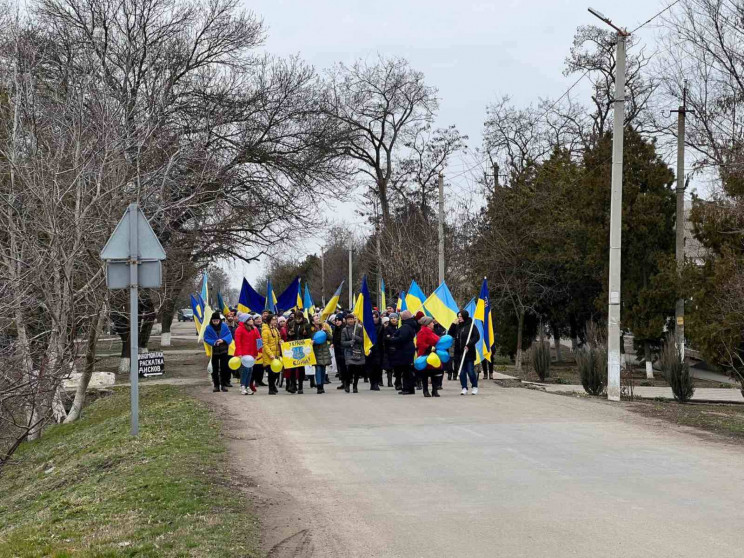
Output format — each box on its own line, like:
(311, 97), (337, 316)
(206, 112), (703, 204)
(589, 8), (630, 401)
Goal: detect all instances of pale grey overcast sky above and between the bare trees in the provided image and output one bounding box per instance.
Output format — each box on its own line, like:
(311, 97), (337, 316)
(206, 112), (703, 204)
(226, 0), (667, 288)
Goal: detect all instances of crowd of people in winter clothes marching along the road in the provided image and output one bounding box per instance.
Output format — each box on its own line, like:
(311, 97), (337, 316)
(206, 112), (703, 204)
(204, 307), (493, 397)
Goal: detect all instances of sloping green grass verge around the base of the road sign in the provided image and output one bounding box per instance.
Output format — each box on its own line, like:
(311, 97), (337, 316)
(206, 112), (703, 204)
(0, 386), (260, 558)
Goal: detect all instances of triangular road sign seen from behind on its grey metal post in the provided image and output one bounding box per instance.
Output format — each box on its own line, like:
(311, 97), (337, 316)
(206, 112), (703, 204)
(101, 203), (165, 436)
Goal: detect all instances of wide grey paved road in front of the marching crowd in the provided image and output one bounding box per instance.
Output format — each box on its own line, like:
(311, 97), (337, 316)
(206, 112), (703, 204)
(196, 382), (744, 558)
